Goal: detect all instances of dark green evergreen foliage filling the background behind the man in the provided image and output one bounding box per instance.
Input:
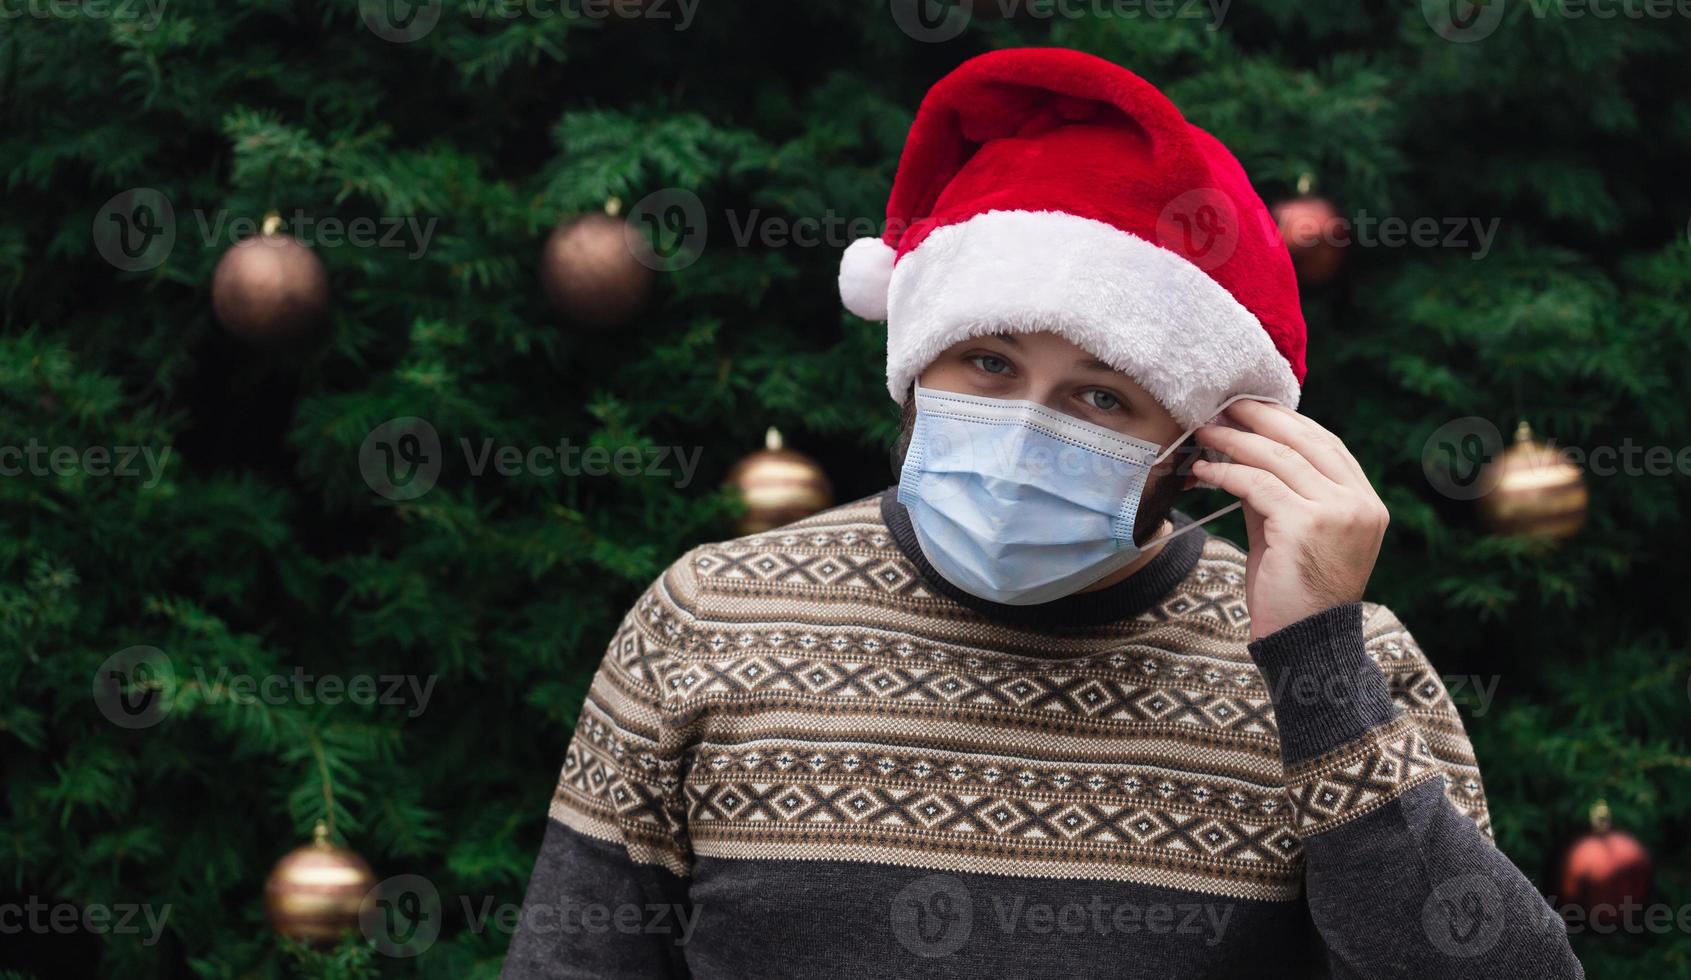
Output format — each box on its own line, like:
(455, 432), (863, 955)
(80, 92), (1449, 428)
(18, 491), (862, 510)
(0, 0), (1691, 980)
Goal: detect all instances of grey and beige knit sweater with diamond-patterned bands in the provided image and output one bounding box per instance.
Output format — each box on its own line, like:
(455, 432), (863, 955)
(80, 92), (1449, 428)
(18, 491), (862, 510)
(504, 490), (1583, 980)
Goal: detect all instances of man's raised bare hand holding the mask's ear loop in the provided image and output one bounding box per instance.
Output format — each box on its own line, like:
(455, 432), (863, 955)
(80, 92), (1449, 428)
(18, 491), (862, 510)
(1192, 400), (1392, 640)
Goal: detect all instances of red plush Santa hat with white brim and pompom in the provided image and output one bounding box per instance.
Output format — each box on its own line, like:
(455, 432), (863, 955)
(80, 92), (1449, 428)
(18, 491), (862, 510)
(839, 47), (1304, 426)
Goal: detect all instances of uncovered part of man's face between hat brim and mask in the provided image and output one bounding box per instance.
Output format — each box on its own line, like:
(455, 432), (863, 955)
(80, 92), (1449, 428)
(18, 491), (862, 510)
(893, 331), (1190, 542)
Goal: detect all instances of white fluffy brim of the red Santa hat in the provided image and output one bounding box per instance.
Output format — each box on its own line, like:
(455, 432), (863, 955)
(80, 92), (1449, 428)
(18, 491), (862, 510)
(879, 211), (1300, 426)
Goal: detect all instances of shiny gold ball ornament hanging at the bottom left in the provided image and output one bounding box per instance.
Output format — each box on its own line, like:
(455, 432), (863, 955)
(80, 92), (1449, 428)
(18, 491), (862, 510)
(264, 819), (375, 945)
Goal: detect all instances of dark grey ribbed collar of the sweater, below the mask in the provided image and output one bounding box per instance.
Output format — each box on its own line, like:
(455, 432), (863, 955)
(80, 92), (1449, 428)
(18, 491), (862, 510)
(881, 485), (1207, 627)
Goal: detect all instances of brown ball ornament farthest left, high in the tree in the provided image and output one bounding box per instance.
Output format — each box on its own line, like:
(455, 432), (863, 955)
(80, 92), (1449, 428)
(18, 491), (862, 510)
(211, 211), (328, 348)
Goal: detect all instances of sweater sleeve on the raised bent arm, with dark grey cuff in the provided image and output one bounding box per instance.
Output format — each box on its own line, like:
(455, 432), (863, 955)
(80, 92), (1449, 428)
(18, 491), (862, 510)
(1250, 603), (1584, 980)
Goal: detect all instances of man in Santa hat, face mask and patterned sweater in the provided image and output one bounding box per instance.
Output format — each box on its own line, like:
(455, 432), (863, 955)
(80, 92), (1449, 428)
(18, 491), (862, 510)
(506, 49), (1583, 980)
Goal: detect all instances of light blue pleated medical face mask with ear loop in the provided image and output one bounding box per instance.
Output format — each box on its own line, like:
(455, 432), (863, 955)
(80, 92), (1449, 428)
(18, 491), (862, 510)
(898, 385), (1253, 605)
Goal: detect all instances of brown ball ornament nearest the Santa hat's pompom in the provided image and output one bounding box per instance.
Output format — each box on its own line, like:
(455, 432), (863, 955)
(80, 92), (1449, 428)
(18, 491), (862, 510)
(539, 198), (656, 328)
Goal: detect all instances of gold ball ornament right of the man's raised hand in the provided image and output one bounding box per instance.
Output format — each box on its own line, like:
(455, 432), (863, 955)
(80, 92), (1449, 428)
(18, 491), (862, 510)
(1480, 421), (1590, 541)
